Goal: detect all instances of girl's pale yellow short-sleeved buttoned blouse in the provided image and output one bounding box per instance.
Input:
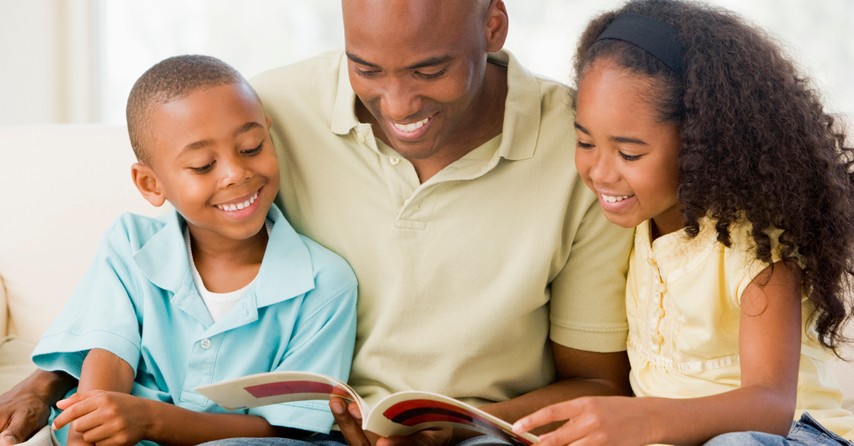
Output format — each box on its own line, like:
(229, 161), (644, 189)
(626, 221), (854, 440)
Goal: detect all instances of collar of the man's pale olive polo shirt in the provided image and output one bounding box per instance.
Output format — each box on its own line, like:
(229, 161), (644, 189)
(331, 50), (540, 164)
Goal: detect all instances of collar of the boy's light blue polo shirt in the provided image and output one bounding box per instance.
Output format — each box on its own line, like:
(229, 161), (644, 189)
(133, 206), (314, 308)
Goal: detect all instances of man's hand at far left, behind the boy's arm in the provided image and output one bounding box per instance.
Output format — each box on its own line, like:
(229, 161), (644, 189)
(0, 369), (77, 446)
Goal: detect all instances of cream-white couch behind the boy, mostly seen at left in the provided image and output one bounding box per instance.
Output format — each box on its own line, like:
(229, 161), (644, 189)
(0, 125), (854, 422)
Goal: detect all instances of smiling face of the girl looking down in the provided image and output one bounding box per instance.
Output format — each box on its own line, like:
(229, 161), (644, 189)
(575, 59), (683, 237)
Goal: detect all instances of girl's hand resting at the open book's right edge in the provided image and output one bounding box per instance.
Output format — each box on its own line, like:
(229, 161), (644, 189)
(513, 397), (655, 446)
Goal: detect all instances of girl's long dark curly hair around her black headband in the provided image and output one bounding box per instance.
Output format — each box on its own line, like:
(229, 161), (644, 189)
(573, 0), (854, 351)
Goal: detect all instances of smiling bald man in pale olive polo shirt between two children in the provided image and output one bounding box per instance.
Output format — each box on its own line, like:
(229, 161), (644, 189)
(0, 0), (631, 445)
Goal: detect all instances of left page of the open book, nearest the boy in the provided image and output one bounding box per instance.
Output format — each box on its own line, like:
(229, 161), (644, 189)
(196, 372), (365, 413)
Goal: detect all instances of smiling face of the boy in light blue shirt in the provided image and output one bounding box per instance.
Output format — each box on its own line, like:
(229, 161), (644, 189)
(134, 84), (279, 248)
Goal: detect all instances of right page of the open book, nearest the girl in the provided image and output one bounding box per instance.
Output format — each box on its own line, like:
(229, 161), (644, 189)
(364, 391), (537, 445)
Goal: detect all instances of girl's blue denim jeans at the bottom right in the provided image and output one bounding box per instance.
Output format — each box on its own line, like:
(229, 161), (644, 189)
(706, 412), (854, 446)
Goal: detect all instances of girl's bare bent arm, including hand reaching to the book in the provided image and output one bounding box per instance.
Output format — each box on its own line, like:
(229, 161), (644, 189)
(515, 262), (801, 446)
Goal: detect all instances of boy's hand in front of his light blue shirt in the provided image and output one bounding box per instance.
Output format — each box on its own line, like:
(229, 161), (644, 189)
(53, 390), (151, 446)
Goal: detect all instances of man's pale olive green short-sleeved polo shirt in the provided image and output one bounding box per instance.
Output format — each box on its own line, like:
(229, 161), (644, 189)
(252, 52), (632, 410)
